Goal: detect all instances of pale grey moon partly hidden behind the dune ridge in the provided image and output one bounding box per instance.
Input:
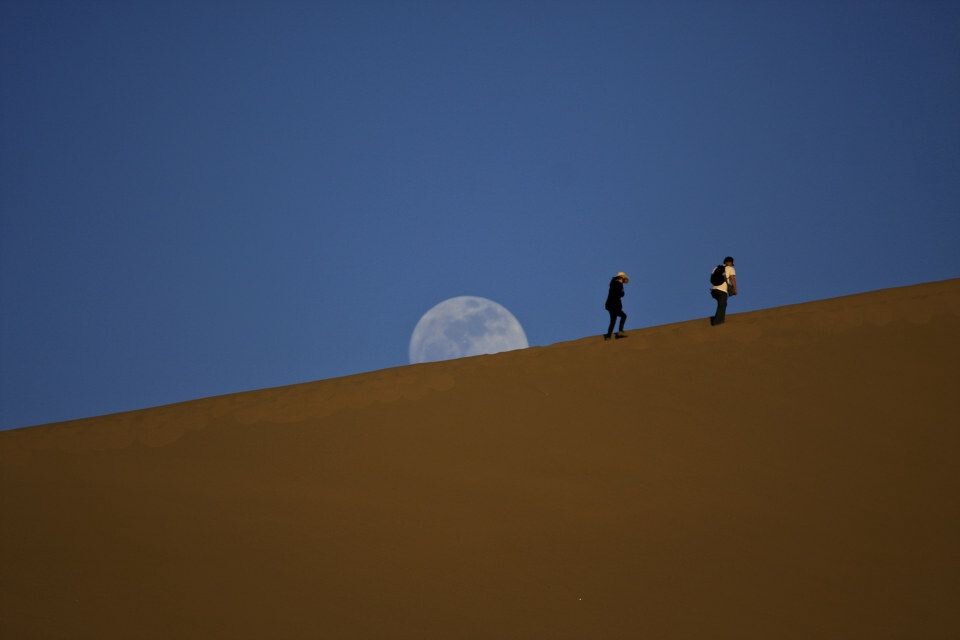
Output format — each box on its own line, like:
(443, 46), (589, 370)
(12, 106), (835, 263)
(410, 296), (530, 364)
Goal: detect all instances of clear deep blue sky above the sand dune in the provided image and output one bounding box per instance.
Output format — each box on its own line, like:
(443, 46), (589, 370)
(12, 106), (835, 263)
(0, 0), (960, 428)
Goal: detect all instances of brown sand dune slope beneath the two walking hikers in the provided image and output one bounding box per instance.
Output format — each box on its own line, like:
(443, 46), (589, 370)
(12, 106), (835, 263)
(0, 280), (960, 639)
